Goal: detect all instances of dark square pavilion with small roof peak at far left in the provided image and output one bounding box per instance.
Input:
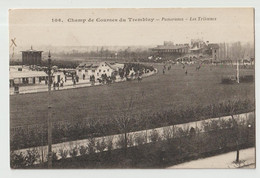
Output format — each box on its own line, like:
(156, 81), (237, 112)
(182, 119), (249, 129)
(21, 47), (43, 65)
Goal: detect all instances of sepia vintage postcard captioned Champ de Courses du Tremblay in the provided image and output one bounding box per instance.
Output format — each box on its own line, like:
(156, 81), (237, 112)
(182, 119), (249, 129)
(9, 8), (256, 169)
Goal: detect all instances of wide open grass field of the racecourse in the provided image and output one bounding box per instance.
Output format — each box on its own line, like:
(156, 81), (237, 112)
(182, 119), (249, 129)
(10, 64), (255, 127)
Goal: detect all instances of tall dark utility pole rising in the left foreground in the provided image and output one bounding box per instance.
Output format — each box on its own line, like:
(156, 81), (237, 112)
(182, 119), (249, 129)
(47, 51), (52, 169)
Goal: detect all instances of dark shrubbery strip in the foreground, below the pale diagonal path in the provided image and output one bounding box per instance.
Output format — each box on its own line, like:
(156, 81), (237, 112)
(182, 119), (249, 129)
(11, 115), (255, 168)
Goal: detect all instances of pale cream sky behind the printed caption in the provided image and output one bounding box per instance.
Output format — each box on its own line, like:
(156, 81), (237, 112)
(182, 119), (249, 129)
(9, 8), (254, 47)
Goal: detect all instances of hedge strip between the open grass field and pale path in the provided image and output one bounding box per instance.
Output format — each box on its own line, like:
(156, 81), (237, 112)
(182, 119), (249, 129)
(10, 100), (254, 150)
